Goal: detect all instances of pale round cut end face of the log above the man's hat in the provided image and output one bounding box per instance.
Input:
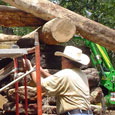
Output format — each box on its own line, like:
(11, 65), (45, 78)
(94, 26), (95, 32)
(52, 18), (76, 42)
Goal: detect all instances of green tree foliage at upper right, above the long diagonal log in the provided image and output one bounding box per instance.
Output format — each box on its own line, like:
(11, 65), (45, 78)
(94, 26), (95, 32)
(59, 0), (115, 29)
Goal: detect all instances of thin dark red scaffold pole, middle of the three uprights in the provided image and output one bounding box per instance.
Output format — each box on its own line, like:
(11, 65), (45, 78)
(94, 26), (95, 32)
(24, 55), (28, 115)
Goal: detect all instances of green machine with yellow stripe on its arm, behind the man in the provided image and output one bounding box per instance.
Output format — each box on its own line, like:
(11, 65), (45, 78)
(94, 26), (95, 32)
(74, 36), (115, 107)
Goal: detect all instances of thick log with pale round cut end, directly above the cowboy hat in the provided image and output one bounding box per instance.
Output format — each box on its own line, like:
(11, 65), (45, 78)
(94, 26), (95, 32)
(38, 18), (76, 45)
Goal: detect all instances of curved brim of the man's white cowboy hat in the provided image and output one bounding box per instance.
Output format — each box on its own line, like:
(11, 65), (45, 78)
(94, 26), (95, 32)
(54, 51), (90, 65)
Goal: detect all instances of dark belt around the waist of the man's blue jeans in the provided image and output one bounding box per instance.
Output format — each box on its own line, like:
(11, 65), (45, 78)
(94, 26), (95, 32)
(60, 109), (93, 115)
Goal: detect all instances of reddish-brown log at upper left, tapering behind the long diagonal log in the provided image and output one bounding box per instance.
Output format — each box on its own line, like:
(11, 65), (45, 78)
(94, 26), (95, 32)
(0, 5), (46, 27)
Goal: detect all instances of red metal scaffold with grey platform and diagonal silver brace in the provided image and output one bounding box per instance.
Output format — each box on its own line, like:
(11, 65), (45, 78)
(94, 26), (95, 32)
(0, 32), (42, 115)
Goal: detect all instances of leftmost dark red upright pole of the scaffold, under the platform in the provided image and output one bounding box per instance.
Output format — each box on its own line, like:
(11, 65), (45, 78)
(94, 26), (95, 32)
(14, 58), (19, 115)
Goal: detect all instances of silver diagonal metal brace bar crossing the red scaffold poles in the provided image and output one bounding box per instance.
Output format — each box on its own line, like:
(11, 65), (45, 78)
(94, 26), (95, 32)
(0, 66), (35, 92)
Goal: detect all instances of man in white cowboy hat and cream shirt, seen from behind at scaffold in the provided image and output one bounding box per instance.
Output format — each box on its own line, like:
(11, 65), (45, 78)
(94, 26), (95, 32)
(22, 46), (93, 115)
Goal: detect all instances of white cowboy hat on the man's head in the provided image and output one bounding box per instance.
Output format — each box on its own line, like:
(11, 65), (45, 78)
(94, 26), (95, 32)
(55, 46), (90, 65)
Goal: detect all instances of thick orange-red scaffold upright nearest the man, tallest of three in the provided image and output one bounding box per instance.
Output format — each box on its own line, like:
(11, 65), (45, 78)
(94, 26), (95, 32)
(35, 32), (42, 115)
